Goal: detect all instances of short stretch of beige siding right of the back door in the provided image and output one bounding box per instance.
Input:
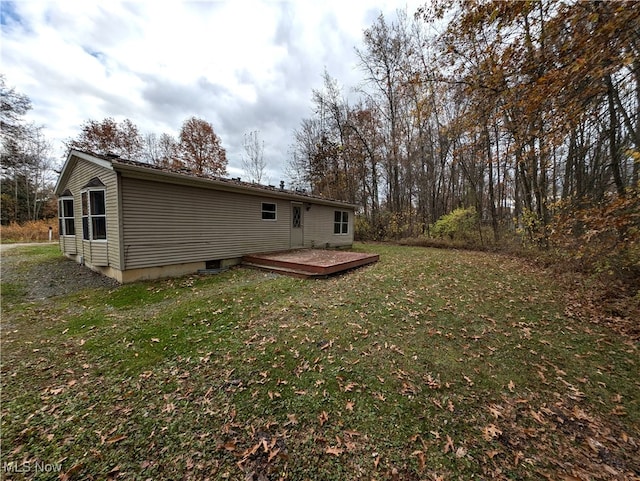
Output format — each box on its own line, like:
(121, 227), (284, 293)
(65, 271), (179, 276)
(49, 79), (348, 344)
(304, 204), (353, 247)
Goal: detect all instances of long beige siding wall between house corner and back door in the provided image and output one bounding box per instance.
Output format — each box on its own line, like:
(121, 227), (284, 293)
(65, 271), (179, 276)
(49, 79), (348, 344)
(121, 177), (291, 269)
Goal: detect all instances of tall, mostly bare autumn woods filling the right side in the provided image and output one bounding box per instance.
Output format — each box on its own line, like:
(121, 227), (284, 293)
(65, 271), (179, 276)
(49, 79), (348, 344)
(289, 0), (640, 255)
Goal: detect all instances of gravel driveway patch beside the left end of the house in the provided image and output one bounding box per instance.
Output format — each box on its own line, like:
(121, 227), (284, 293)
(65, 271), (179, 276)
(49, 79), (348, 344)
(0, 244), (120, 300)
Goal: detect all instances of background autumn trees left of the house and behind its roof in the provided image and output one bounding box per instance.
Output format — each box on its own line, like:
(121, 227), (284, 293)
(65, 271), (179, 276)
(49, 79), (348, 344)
(0, 75), (266, 225)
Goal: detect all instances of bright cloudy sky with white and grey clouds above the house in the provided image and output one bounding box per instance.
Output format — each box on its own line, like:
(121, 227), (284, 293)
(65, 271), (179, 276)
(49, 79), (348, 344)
(5, 0), (423, 184)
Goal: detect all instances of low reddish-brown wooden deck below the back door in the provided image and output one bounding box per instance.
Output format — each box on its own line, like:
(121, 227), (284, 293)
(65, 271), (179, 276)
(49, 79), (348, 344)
(242, 249), (380, 279)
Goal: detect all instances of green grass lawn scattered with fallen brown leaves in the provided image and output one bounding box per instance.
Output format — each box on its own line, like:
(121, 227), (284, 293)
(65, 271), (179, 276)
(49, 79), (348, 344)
(2, 245), (640, 480)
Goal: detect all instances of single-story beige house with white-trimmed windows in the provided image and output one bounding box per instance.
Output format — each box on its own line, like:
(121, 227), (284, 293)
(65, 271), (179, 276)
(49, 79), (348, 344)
(56, 150), (356, 283)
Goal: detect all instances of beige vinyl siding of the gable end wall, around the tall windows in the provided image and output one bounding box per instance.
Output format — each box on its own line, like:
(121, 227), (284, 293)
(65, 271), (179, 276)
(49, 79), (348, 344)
(60, 158), (121, 269)
